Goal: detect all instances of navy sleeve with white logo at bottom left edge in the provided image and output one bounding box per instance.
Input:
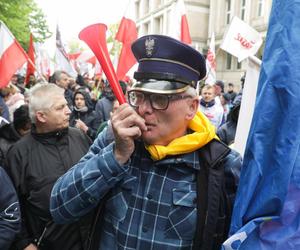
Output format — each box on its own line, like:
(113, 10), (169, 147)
(0, 167), (21, 250)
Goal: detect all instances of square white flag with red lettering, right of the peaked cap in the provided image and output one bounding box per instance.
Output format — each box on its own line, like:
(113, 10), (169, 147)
(220, 16), (263, 62)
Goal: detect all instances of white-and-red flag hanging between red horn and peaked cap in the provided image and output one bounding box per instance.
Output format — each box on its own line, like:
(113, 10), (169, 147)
(116, 0), (138, 80)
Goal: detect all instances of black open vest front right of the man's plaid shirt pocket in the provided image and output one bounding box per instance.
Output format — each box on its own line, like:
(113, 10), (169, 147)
(193, 140), (230, 250)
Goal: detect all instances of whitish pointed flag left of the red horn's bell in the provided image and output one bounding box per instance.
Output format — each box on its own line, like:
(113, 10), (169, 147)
(55, 26), (77, 77)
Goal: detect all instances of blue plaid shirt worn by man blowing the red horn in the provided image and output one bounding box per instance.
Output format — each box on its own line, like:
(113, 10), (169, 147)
(51, 128), (238, 250)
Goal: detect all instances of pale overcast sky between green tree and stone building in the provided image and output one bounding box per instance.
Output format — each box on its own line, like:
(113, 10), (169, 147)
(35, 0), (128, 52)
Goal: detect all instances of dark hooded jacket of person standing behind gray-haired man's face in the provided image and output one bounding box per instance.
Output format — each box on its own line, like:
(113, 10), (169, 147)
(70, 89), (101, 140)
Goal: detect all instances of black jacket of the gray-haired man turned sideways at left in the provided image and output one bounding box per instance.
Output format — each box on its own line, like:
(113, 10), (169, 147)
(7, 127), (91, 250)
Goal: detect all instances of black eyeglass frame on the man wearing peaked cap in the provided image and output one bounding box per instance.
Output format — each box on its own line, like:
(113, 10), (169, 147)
(127, 90), (192, 110)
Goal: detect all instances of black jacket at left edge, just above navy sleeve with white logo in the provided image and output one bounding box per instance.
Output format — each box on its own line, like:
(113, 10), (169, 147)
(0, 123), (21, 166)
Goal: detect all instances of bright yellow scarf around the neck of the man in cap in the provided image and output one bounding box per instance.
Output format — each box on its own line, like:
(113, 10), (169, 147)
(145, 111), (218, 161)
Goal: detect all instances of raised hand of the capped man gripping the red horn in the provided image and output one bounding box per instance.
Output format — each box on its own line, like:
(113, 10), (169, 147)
(111, 103), (147, 165)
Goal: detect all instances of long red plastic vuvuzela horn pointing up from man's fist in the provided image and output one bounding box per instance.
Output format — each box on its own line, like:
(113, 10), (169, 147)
(79, 23), (126, 104)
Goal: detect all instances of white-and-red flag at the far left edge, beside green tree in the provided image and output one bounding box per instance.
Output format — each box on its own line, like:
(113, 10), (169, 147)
(0, 21), (27, 88)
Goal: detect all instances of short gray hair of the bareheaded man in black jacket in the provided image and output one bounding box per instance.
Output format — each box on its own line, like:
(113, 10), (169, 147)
(28, 83), (64, 123)
